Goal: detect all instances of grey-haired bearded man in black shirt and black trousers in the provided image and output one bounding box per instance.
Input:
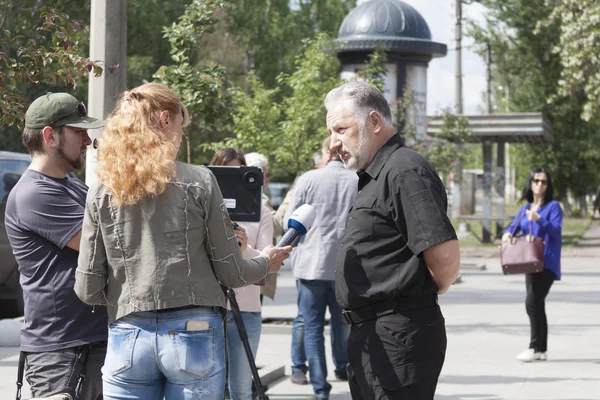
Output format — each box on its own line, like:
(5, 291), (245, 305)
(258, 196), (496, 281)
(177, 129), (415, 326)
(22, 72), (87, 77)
(325, 82), (460, 400)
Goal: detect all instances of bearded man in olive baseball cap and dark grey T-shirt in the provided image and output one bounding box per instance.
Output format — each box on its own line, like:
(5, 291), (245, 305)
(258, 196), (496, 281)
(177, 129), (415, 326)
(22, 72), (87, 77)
(5, 93), (107, 400)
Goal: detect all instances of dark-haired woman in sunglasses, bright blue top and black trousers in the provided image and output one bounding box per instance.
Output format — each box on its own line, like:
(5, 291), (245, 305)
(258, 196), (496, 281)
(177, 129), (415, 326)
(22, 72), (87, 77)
(502, 168), (562, 362)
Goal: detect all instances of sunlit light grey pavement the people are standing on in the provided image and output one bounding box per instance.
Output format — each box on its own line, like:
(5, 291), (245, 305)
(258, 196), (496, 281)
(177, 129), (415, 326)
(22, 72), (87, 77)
(0, 225), (600, 400)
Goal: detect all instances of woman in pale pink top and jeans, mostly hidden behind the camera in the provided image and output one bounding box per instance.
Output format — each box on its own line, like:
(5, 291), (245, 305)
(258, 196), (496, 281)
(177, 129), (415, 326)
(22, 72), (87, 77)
(210, 147), (276, 400)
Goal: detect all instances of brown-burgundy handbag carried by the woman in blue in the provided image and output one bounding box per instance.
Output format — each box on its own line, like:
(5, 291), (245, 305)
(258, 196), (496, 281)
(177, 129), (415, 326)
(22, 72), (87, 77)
(500, 212), (544, 275)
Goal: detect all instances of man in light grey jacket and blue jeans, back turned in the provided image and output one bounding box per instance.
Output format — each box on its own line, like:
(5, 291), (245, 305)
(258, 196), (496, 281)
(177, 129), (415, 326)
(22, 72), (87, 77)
(285, 137), (358, 399)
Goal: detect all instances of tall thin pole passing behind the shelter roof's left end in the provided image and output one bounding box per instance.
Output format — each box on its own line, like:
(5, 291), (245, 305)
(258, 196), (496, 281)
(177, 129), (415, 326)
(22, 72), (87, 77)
(450, 0), (463, 216)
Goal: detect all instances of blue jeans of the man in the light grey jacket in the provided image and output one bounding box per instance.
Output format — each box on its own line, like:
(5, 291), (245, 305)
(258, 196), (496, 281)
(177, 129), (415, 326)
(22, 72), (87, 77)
(298, 279), (348, 398)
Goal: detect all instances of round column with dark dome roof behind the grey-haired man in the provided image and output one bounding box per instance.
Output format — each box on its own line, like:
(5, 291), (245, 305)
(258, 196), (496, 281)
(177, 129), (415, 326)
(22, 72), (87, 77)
(336, 0), (447, 139)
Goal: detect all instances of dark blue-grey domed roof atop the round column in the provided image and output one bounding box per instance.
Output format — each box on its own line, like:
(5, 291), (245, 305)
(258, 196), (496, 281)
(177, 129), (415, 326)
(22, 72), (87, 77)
(336, 0), (447, 57)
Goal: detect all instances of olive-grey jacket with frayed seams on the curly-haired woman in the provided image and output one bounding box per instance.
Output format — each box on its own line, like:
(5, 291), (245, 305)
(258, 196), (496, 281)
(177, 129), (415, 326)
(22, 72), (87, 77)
(75, 162), (269, 323)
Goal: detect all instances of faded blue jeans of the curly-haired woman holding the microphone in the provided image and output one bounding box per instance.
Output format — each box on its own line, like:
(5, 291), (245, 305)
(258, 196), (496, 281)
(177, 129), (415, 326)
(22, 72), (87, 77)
(102, 307), (225, 400)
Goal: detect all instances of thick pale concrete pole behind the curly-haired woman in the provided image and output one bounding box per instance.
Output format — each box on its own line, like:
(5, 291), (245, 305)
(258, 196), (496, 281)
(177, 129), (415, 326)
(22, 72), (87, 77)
(85, 0), (127, 186)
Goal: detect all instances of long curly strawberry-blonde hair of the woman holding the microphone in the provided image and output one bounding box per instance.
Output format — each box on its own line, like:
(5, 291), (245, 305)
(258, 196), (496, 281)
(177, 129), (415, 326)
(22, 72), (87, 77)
(98, 83), (189, 206)
